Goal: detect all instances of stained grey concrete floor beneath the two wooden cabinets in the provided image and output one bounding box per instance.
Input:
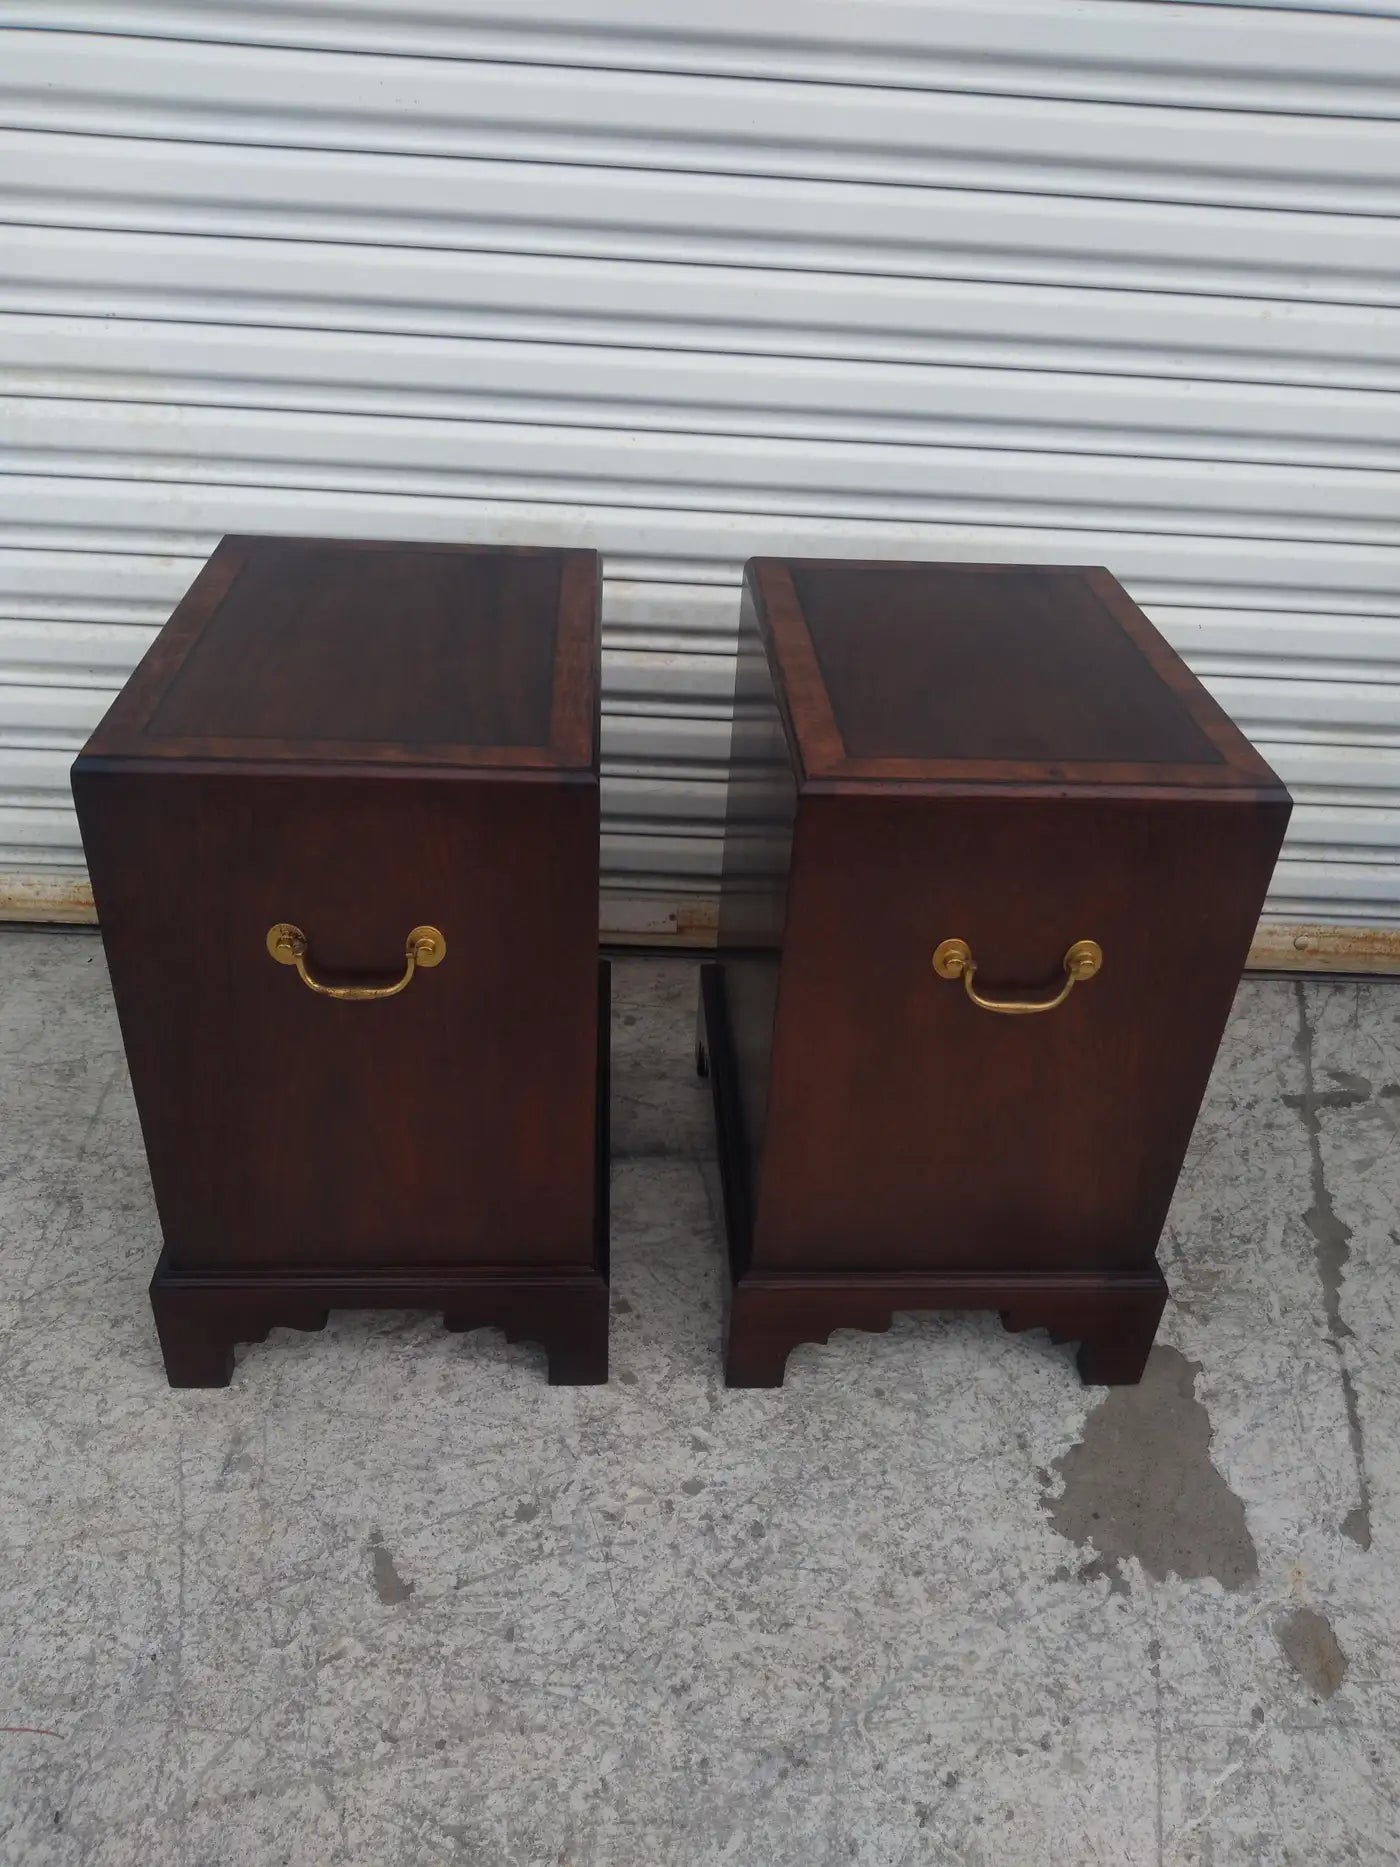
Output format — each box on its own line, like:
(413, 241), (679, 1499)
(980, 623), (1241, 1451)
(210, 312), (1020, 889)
(0, 930), (1400, 1867)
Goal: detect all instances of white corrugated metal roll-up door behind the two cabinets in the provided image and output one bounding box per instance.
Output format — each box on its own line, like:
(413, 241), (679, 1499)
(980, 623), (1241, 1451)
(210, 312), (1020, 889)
(0, 0), (1400, 956)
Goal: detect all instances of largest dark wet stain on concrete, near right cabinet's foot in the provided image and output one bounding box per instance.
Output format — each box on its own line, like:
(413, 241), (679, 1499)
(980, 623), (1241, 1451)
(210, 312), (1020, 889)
(1042, 1346), (1258, 1589)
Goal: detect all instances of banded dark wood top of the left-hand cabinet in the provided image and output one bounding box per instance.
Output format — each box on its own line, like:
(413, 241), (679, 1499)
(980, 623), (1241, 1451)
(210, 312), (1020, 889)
(79, 538), (597, 765)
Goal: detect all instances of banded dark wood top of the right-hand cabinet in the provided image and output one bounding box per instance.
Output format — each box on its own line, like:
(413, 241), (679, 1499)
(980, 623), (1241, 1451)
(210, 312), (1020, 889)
(749, 558), (1277, 788)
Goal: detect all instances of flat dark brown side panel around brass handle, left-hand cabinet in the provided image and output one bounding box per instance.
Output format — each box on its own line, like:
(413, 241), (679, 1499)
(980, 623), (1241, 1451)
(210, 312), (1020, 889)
(78, 773), (597, 1270)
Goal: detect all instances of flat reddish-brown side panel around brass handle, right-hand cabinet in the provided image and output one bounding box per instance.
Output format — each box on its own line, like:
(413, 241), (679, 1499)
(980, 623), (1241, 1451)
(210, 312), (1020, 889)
(754, 797), (1288, 1271)
